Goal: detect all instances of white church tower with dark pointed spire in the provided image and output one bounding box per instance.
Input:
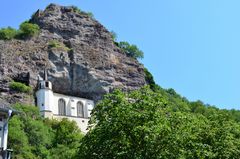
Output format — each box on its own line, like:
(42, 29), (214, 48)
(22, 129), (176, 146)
(36, 69), (53, 118)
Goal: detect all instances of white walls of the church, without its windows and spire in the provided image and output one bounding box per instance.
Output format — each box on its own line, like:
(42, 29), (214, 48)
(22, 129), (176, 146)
(36, 89), (94, 133)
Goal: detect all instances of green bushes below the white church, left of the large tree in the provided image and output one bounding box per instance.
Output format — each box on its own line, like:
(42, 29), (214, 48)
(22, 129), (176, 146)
(8, 104), (82, 159)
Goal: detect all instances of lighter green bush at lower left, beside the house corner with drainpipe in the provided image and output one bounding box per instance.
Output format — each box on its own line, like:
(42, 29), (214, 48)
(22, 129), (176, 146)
(9, 104), (52, 159)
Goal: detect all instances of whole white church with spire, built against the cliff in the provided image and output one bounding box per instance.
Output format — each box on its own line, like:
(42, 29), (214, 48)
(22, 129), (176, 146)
(36, 70), (94, 133)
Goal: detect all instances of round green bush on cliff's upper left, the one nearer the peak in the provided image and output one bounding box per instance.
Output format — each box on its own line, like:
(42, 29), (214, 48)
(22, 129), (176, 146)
(19, 22), (40, 38)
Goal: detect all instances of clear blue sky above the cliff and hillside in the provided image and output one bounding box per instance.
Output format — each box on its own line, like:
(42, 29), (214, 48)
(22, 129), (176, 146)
(0, 0), (240, 109)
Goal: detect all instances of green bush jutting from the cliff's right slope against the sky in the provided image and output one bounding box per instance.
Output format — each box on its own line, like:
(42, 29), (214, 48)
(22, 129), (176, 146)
(118, 41), (144, 59)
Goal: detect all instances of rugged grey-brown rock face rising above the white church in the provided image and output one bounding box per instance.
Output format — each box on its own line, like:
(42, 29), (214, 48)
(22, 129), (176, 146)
(0, 4), (146, 103)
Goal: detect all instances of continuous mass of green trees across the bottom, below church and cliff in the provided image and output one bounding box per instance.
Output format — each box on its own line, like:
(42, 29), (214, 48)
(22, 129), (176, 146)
(9, 81), (240, 159)
